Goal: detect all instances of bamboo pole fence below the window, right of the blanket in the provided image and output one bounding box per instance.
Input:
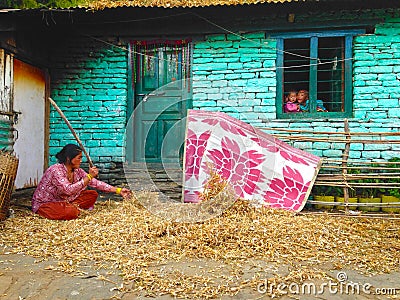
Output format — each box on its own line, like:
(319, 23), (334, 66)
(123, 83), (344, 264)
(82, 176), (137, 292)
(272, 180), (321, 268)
(260, 119), (400, 213)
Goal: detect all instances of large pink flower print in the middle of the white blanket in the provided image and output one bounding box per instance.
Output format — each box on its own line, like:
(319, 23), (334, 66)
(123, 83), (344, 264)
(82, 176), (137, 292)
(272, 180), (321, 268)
(203, 137), (265, 197)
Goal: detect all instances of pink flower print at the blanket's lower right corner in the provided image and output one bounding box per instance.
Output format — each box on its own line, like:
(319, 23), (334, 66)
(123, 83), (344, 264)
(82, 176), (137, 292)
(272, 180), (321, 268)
(264, 167), (310, 211)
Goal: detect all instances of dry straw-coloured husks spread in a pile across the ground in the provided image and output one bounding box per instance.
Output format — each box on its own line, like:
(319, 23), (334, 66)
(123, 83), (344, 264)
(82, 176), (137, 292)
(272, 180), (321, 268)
(0, 192), (400, 299)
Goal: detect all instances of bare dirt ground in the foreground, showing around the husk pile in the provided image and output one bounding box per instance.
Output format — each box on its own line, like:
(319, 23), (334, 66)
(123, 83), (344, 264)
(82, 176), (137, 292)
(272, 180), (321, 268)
(0, 254), (400, 300)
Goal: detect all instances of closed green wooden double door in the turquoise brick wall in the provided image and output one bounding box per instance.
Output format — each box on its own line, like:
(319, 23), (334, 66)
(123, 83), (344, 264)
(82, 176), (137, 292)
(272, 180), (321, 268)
(133, 44), (191, 162)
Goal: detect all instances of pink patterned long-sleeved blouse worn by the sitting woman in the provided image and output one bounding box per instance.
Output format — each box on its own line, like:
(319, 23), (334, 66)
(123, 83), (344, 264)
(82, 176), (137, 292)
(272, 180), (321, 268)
(32, 163), (112, 212)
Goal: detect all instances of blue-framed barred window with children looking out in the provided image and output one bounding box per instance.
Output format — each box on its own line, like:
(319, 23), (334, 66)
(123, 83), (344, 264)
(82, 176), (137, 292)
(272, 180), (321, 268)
(277, 31), (362, 118)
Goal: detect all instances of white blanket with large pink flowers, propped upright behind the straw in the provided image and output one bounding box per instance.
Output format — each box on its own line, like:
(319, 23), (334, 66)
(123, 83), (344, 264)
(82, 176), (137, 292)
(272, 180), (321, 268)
(184, 110), (322, 212)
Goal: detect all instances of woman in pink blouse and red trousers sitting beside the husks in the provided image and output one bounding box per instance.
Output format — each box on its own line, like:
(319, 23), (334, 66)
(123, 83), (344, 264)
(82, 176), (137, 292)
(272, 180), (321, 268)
(32, 144), (131, 220)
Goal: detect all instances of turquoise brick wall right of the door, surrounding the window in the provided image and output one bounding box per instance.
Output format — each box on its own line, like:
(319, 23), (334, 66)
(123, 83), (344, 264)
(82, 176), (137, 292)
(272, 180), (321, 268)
(193, 12), (400, 161)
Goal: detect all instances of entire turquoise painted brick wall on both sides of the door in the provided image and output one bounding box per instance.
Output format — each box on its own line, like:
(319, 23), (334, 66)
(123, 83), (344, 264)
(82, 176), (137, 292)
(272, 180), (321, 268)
(50, 12), (400, 167)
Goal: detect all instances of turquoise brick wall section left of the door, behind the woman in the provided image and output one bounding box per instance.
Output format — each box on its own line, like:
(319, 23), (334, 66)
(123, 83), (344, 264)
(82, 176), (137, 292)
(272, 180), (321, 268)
(49, 39), (128, 168)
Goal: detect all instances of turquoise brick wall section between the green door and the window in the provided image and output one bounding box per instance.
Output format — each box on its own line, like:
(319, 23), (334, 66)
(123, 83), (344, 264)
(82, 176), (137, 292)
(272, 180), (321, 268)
(193, 33), (276, 126)
